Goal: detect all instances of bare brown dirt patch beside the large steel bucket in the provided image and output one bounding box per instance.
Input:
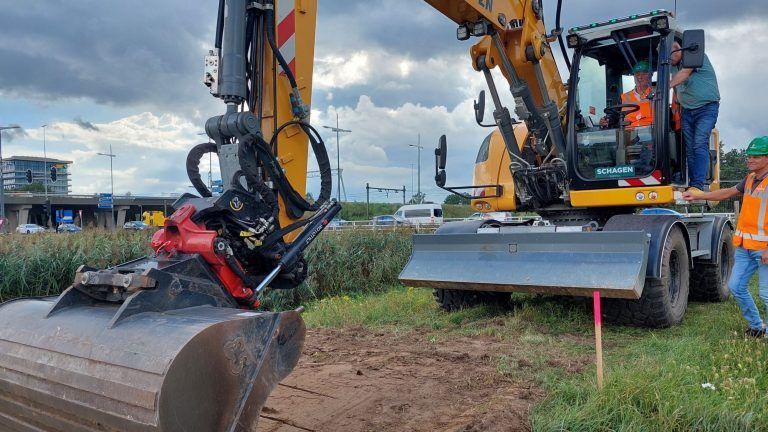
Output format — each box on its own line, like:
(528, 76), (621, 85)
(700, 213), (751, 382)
(259, 328), (587, 432)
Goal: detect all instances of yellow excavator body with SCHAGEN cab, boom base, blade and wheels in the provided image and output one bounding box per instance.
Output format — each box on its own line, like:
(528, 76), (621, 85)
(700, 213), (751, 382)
(400, 0), (734, 327)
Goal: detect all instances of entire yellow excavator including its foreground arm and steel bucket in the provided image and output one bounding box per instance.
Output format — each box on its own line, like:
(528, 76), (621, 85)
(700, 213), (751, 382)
(0, 0), (732, 432)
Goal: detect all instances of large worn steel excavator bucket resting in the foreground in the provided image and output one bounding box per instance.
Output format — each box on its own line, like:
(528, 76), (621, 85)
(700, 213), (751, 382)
(0, 288), (305, 432)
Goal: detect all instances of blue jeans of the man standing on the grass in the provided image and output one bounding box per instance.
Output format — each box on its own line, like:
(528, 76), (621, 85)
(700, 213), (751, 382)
(728, 246), (768, 329)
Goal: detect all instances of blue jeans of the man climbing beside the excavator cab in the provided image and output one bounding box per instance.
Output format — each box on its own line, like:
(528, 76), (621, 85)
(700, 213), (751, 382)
(683, 102), (720, 190)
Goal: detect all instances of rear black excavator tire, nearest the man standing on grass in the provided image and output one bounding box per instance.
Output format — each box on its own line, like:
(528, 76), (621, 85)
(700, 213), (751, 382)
(691, 225), (736, 302)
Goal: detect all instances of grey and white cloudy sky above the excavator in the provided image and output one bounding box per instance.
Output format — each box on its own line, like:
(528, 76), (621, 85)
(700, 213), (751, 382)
(0, 0), (768, 201)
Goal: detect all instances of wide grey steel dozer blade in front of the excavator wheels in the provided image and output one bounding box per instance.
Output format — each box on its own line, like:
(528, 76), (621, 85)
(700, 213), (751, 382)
(400, 231), (649, 299)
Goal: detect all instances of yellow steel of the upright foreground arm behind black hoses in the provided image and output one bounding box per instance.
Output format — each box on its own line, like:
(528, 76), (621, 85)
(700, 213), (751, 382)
(261, 0), (317, 242)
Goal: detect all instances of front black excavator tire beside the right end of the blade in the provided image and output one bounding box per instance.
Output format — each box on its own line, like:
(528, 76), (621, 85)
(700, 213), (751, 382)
(603, 228), (690, 327)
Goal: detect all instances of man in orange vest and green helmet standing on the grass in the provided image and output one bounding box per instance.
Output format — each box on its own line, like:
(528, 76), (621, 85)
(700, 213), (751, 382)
(683, 136), (768, 337)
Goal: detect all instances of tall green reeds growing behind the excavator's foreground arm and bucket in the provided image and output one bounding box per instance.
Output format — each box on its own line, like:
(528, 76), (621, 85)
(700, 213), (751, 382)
(0, 230), (412, 309)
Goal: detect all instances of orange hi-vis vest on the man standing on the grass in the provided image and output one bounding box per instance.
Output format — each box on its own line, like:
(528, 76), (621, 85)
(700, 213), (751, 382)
(733, 173), (768, 250)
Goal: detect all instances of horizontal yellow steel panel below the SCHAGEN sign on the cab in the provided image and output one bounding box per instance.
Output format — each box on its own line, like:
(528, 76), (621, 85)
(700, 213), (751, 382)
(571, 186), (675, 207)
